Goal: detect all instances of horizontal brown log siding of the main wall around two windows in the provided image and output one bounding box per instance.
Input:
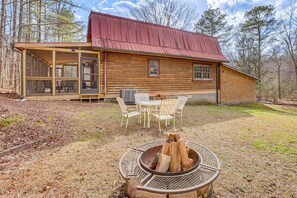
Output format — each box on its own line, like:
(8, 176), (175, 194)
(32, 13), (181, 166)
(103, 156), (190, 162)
(102, 52), (216, 94)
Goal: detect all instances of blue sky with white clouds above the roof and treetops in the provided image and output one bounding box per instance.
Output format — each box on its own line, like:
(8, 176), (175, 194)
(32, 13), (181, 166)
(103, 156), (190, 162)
(74, 0), (297, 29)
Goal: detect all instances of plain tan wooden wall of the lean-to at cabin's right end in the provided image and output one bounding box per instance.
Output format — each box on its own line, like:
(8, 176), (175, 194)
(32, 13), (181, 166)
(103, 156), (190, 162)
(221, 66), (256, 104)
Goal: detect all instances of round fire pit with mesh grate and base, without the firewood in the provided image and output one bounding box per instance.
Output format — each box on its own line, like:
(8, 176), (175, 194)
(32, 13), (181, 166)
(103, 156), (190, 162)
(119, 141), (220, 198)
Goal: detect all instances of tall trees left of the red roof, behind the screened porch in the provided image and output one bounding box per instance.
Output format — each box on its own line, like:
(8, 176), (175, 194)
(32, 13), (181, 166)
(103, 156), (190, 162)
(0, 0), (86, 93)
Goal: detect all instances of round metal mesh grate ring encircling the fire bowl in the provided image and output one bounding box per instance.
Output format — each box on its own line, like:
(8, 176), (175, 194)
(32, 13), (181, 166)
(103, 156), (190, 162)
(119, 141), (220, 194)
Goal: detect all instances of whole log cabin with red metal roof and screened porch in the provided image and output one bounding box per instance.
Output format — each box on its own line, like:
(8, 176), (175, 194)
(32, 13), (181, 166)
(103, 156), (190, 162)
(15, 11), (256, 104)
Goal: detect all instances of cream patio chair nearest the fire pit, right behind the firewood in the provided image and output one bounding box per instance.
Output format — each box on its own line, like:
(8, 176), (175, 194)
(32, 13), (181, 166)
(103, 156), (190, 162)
(153, 99), (178, 133)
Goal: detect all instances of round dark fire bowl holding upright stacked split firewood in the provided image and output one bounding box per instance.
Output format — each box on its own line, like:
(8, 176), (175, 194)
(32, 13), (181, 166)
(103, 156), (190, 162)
(140, 133), (201, 175)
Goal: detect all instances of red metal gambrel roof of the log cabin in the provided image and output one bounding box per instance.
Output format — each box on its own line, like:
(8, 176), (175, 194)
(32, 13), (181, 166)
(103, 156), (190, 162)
(87, 11), (228, 62)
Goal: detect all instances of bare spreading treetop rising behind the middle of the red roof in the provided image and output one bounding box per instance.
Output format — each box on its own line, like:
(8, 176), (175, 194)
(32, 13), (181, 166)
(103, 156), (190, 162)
(130, 0), (197, 29)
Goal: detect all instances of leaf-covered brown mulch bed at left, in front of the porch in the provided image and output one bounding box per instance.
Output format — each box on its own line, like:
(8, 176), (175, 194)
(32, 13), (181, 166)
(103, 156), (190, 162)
(0, 94), (72, 151)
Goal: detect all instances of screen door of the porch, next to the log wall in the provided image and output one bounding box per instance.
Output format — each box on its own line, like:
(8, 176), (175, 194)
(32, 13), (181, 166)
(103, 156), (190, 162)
(80, 57), (98, 94)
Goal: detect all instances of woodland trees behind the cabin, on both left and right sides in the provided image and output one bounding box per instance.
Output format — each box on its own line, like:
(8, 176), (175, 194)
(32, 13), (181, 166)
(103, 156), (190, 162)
(0, 0), (297, 101)
